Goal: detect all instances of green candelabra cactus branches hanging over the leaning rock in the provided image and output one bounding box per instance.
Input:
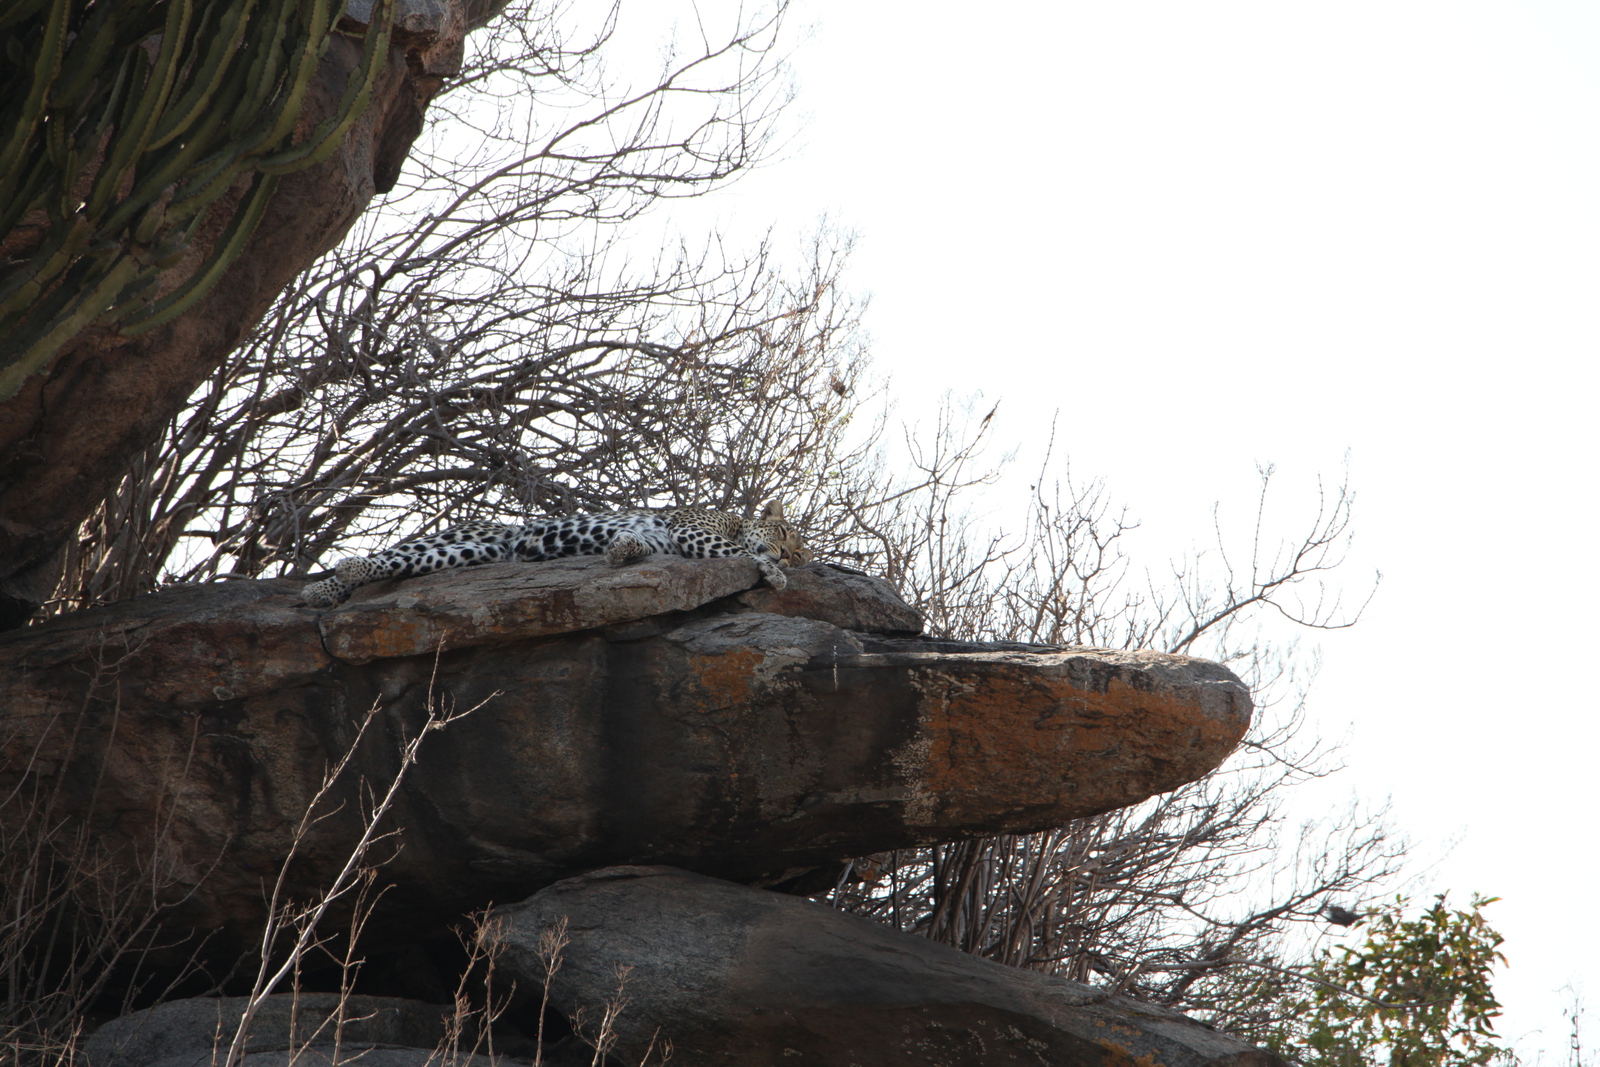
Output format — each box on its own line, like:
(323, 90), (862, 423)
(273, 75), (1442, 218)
(0, 0), (394, 400)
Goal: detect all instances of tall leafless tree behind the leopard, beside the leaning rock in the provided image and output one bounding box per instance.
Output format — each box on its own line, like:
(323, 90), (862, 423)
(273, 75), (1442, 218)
(54, 0), (838, 609)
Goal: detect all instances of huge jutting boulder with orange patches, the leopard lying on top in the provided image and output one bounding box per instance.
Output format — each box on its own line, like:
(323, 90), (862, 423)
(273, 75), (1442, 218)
(0, 557), (1251, 966)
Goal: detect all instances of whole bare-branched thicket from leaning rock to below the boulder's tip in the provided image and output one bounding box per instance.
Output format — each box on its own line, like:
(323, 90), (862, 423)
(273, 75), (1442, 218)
(28, 0), (1402, 1043)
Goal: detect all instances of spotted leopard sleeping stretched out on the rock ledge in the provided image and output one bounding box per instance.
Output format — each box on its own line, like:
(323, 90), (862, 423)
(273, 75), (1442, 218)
(301, 499), (813, 608)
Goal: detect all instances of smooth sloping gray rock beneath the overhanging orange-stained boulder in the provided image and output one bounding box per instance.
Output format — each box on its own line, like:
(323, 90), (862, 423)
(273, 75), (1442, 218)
(493, 867), (1283, 1067)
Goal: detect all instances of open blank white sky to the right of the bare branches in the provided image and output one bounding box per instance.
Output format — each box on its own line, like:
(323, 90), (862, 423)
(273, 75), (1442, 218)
(601, 0), (1600, 1062)
